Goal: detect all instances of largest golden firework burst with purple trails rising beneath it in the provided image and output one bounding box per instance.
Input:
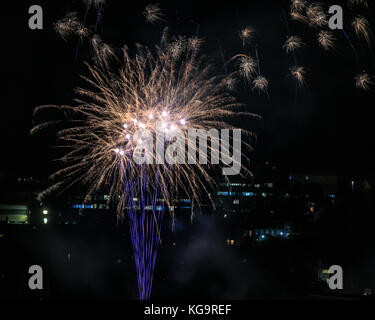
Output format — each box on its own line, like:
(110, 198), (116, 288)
(32, 36), (255, 299)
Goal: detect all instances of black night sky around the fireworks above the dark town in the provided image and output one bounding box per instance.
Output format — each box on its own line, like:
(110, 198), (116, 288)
(0, 0), (375, 180)
